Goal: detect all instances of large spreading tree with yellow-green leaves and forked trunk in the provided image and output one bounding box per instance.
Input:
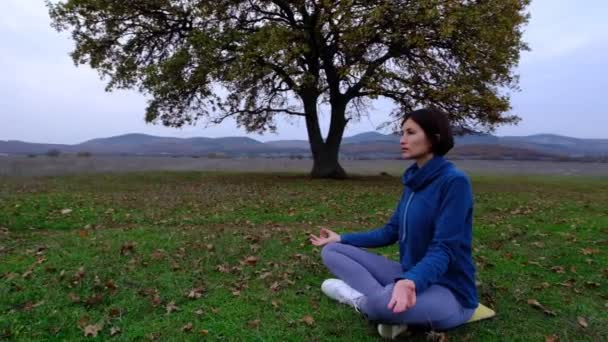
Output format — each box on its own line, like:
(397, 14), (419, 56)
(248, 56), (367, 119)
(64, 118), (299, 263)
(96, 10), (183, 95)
(47, 0), (529, 178)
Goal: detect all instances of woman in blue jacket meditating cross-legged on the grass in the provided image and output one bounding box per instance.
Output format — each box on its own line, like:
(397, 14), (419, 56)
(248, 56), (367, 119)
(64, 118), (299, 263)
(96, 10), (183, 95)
(310, 109), (478, 338)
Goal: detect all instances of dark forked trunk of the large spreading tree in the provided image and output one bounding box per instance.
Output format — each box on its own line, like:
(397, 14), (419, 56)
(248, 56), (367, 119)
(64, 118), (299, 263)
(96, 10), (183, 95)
(304, 93), (347, 179)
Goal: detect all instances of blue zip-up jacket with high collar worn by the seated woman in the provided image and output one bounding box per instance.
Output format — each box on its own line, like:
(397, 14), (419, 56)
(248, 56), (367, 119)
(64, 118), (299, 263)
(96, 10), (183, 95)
(341, 156), (478, 308)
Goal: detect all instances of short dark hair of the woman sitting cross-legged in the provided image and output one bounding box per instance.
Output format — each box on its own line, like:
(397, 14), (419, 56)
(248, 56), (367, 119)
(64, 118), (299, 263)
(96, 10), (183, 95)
(401, 107), (454, 156)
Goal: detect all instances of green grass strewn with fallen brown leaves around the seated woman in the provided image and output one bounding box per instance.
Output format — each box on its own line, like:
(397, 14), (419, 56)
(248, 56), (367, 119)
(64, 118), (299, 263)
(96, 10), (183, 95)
(0, 172), (608, 341)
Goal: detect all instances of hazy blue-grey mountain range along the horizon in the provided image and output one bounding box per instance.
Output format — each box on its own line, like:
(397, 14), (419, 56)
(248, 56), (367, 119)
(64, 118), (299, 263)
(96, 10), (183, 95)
(0, 132), (608, 161)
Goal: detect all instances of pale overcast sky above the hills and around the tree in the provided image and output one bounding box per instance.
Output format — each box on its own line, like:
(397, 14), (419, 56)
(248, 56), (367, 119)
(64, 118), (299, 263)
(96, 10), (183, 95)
(0, 0), (608, 144)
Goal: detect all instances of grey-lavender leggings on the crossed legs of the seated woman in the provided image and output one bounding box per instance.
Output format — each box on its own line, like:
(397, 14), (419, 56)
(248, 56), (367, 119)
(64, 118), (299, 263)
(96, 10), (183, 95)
(321, 243), (475, 330)
